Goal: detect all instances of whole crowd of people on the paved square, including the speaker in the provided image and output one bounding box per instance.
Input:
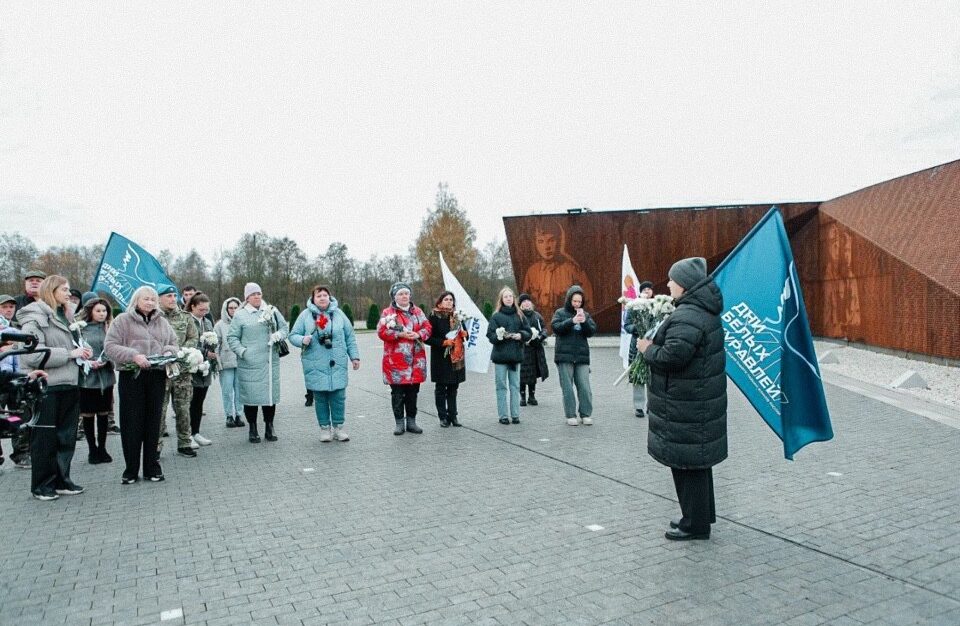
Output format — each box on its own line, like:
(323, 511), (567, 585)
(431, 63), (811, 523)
(0, 258), (727, 540)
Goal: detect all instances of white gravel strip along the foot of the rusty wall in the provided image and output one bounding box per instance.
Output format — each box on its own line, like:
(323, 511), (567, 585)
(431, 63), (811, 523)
(814, 341), (960, 408)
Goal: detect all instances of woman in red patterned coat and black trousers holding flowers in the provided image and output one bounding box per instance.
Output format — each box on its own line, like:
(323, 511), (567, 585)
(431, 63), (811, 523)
(377, 282), (431, 435)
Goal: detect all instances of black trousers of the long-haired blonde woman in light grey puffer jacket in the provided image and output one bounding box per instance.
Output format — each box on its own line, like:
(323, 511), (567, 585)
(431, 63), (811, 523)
(30, 385), (80, 493)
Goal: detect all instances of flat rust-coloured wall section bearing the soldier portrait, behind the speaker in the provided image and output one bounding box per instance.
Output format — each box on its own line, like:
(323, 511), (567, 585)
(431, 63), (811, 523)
(503, 202), (817, 333)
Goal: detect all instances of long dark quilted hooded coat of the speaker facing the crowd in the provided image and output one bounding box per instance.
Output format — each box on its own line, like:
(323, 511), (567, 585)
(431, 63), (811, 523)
(643, 278), (727, 469)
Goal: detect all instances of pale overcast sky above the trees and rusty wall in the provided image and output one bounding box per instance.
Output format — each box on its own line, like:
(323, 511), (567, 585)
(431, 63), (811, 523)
(0, 0), (960, 259)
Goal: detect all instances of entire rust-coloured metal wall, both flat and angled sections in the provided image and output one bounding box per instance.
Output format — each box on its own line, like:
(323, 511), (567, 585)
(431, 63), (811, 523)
(503, 161), (960, 359)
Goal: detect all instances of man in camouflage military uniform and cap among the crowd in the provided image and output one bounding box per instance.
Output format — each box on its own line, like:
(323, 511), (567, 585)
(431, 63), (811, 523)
(157, 286), (199, 457)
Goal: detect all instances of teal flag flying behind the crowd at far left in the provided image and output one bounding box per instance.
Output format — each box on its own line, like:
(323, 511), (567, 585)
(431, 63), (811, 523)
(90, 233), (179, 309)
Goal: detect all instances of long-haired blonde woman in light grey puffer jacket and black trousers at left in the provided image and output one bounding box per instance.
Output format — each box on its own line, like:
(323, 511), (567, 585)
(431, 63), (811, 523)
(17, 274), (93, 500)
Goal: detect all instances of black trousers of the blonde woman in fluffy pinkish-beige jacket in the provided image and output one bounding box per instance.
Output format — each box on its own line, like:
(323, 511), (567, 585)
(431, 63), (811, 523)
(117, 370), (167, 478)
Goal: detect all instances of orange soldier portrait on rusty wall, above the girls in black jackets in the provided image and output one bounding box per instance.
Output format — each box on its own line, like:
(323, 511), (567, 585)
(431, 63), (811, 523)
(520, 218), (593, 311)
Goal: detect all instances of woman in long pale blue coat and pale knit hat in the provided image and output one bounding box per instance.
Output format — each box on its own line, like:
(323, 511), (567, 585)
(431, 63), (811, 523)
(227, 283), (287, 443)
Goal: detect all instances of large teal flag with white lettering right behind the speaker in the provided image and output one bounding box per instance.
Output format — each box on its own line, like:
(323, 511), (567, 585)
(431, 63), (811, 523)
(713, 207), (833, 460)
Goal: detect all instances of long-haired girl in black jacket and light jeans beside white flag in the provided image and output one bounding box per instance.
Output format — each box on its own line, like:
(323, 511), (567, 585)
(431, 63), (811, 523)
(487, 287), (531, 424)
